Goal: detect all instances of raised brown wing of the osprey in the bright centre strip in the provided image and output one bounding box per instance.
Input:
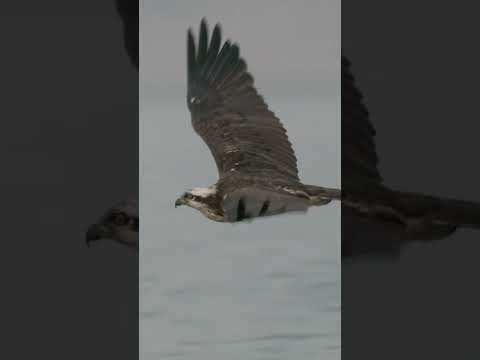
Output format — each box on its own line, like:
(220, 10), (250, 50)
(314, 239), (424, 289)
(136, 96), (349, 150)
(187, 19), (298, 181)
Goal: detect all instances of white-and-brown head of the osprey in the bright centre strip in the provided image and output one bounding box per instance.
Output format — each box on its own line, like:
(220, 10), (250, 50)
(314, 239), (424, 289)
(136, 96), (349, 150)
(175, 186), (223, 221)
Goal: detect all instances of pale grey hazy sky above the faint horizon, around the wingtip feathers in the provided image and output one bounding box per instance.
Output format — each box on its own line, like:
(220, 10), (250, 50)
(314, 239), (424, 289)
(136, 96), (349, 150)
(140, 0), (340, 101)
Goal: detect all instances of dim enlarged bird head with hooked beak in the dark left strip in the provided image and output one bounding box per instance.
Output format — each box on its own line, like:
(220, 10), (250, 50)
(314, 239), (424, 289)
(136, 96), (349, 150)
(86, 200), (139, 250)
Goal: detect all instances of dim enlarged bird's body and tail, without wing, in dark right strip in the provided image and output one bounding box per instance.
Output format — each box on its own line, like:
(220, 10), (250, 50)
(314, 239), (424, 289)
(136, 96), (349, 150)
(342, 187), (480, 257)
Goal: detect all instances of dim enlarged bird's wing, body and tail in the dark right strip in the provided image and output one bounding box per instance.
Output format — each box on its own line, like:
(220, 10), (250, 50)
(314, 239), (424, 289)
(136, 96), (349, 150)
(342, 57), (480, 257)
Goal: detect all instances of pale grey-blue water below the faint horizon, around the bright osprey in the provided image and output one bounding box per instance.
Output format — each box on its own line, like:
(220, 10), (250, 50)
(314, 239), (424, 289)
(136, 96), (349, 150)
(140, 97), (340, 360)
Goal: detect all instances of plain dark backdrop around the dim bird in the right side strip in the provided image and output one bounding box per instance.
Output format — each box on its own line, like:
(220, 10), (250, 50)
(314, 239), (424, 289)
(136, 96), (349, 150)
(342, 0), (480, 360)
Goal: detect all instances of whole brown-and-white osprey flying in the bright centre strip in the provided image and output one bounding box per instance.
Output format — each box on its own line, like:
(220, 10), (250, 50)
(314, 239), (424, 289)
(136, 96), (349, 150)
(175, 19), (340, 222)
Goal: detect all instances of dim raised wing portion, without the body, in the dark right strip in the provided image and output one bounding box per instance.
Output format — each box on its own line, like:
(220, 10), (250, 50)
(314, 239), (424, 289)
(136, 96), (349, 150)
(342, 56), (383, 185)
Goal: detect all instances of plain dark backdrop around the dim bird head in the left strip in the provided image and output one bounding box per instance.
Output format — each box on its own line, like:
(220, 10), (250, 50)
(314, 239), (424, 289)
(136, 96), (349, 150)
(0, 0), (138, 360)
